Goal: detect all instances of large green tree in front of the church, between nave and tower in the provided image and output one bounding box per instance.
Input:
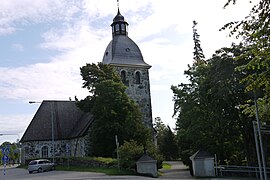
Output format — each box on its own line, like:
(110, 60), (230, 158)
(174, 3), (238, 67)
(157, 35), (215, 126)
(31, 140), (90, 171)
(78, 63), (149, 157)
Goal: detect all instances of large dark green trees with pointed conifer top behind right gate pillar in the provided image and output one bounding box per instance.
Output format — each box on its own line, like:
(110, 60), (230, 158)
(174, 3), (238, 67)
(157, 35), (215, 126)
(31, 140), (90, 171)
(171, 18), (262, 164)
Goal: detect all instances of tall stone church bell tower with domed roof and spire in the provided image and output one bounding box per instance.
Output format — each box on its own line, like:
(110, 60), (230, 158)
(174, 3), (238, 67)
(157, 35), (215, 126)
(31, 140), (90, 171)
(102, 7), (153, 128)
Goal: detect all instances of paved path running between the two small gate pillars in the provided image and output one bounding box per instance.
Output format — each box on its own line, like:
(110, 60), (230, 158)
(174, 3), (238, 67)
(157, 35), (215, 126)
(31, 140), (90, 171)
(158, 161), (258, 180)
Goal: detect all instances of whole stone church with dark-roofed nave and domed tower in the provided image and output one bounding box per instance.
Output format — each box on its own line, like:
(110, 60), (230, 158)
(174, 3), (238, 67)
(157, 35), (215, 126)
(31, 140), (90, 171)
(20, 7), (153, 162)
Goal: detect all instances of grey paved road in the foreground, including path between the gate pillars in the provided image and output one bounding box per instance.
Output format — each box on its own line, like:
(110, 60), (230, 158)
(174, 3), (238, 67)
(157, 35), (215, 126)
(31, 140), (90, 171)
(0, 161), (260, 180)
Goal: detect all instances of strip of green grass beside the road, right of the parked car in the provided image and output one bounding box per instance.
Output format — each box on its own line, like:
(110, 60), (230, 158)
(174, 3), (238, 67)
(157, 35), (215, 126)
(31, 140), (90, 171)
(56, 165), (136, 175)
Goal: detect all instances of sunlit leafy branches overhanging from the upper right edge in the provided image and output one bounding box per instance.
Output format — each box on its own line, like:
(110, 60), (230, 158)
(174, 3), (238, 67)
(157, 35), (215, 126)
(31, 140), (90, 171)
(222, 0), (270, 97)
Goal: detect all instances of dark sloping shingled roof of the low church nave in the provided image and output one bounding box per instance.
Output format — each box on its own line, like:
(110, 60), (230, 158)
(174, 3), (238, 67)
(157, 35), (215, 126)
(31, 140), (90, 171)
(21, 101), (93, 142)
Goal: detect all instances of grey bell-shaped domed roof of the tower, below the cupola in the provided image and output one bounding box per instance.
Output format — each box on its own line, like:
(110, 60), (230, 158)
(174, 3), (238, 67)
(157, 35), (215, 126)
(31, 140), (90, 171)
(102, 35), (151, 68)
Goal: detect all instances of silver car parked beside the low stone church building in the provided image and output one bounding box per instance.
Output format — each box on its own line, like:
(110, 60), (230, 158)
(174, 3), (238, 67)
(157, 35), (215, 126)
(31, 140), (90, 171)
(28, 159), (55, 174)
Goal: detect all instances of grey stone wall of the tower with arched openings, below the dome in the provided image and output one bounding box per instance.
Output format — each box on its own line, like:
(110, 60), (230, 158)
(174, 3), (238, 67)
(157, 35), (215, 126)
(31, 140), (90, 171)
(115, 67), (153, 128)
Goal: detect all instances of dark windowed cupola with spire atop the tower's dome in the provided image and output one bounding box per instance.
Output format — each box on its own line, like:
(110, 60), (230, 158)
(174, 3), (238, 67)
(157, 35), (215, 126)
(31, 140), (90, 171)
(111, 7), (128, 38)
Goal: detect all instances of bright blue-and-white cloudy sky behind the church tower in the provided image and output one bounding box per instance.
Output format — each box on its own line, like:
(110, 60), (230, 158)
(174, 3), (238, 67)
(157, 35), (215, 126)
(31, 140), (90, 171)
(0, 0), (258, 144)
